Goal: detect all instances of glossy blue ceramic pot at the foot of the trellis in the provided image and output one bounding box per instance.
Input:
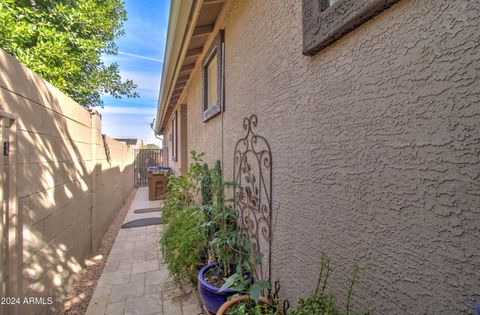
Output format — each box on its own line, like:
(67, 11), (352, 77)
(198, 263), (238, 314)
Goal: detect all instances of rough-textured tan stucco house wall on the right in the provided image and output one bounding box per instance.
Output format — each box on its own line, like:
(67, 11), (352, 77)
(162, 0), (480, 314)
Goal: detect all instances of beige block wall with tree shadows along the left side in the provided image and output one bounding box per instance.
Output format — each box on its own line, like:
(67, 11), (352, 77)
(0, 50), (133, 314)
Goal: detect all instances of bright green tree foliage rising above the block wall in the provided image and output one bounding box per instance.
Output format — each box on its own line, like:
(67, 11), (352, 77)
(0, 0), (139, 107)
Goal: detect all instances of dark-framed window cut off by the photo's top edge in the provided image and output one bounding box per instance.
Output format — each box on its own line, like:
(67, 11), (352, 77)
(303, 0), (399, 56)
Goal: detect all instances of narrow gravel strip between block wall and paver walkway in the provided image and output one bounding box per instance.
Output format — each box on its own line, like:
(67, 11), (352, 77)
(58, 189), (137, 315)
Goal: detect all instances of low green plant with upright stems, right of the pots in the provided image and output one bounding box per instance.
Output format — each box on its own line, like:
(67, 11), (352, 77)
(288, 253), (368, 315)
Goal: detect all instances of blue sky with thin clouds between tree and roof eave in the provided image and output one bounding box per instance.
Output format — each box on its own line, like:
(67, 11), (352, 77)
(99, 0), (170, 144)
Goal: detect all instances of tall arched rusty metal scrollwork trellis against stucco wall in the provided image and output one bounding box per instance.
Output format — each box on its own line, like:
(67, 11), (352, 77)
(233, 115), (272, 282)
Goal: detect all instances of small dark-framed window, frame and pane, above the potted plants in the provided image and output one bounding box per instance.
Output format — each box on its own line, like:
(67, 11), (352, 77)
(202, 31), (224, 122)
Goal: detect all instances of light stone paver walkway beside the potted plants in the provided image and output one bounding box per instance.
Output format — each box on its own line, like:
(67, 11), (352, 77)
(86, 188), (202, 315)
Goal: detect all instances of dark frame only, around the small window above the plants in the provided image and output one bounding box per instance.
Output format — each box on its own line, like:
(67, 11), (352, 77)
(202, 30), (225, 122)
